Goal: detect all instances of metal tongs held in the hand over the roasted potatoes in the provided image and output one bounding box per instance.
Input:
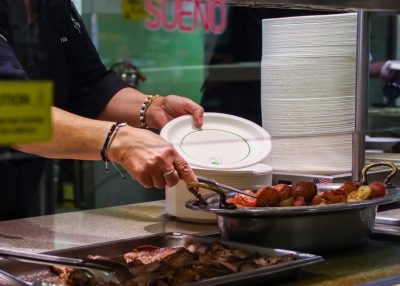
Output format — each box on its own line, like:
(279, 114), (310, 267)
(188, 176), (268, 209)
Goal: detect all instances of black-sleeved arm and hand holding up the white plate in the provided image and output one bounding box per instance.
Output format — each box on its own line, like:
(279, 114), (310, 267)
(58, 1), (203, 129)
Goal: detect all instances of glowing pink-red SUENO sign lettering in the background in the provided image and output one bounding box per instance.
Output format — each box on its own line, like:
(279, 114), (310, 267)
(144, 0), (227, 34)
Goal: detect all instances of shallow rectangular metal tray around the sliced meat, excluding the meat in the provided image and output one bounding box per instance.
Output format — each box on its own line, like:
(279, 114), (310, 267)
(0, 233), (323, 286)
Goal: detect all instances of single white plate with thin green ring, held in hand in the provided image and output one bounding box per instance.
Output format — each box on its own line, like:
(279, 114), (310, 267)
(160, 112), (271, 169)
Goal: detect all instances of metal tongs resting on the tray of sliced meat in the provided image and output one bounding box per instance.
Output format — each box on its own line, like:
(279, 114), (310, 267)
(0, 248), (133, 285)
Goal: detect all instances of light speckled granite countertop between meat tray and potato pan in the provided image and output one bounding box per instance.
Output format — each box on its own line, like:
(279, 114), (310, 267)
(0, 201), (218, 252)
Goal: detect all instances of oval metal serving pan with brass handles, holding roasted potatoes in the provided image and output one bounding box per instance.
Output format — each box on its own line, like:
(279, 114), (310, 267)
(186, 162), (400, 253)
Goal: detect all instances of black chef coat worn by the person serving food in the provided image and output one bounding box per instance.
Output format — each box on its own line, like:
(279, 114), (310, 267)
(0, 0), (128, 220)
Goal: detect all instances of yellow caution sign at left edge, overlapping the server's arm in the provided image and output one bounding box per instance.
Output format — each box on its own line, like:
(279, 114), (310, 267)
(0, 81), (53, 146)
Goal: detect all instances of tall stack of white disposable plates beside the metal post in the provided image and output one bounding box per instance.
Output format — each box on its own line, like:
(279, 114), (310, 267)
(261, 13), (357, 174)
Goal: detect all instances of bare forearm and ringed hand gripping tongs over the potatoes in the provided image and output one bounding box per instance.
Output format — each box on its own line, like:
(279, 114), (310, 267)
(13, 107), (197, 188)
